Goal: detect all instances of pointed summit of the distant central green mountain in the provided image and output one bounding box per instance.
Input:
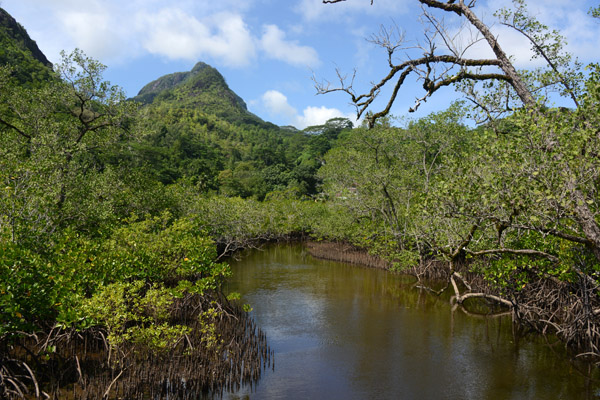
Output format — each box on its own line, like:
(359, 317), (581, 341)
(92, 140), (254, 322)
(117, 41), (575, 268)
(133, 62), (275, 128)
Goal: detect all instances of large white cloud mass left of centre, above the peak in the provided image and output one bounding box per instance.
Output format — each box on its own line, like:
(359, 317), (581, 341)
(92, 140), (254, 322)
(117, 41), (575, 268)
(9, 0), (319, 67)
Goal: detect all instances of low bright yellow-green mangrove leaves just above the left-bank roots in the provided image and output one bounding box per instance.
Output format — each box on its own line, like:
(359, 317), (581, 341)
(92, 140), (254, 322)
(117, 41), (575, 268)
(0, 214), (230, 334)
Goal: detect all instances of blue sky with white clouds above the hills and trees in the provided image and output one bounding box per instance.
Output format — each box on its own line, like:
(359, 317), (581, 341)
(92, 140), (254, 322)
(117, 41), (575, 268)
(0, 0), (600, 129)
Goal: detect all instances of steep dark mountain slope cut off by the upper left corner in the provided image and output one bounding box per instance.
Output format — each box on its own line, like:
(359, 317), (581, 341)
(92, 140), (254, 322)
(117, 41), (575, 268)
(0, 8), (52, 85)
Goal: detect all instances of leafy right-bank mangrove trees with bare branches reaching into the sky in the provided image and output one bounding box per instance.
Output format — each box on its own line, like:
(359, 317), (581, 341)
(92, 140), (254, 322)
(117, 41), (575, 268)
(318, 0), (600, 356)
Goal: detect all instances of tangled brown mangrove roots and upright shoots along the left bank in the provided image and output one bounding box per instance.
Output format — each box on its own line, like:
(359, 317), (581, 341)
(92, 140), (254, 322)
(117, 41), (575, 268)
(0, 295), (273, 400)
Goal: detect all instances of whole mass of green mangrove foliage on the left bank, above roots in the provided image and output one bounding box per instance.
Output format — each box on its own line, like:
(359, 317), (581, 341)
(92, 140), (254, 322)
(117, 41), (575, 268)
(0, 50), (236, 354)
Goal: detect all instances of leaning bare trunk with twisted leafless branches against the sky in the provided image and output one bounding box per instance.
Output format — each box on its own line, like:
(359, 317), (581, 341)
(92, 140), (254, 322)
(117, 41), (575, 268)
(315, 0), (536, 126)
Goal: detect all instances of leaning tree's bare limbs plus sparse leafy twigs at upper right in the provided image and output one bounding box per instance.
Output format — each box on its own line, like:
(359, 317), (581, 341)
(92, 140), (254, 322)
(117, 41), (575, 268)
(315, 0), (575, 126)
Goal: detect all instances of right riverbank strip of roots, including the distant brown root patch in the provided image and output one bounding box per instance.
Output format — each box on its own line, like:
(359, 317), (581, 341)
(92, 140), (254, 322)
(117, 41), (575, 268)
(306, 241), (600, 365)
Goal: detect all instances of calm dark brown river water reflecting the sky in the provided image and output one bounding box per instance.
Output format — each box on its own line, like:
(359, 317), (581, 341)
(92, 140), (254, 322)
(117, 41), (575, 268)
(225, 245), (600, 400)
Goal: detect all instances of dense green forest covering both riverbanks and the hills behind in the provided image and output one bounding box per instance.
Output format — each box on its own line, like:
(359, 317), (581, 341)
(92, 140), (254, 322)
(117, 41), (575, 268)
(0, 0), (600, 399)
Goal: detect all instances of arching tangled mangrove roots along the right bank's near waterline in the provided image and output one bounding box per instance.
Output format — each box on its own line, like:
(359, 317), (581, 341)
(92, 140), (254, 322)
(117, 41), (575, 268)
(413, 261), (600, 364)
